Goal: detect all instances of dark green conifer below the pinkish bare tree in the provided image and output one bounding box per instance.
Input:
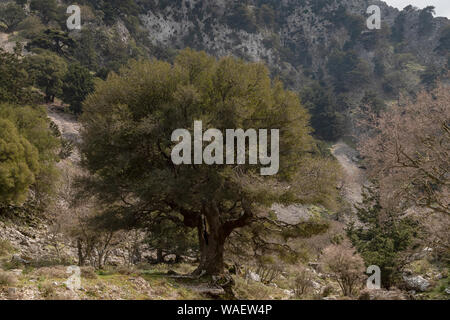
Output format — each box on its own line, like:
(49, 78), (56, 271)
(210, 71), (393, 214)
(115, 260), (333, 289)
(347, 187), (420, 288)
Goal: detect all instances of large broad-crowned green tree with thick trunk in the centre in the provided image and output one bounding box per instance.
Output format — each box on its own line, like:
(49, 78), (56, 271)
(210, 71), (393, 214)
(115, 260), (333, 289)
(81, 50), (336, 274)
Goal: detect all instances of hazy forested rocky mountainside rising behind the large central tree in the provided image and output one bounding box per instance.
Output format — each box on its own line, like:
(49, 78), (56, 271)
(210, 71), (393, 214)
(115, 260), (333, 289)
(1, 0), (450, 140)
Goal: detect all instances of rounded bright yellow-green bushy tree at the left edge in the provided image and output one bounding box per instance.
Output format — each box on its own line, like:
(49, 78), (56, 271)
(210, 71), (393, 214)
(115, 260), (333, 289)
(0, 105), (60, 203)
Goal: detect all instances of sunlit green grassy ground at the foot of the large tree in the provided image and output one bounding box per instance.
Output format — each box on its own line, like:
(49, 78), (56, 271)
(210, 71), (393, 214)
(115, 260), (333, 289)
(0, 252), (289, 300)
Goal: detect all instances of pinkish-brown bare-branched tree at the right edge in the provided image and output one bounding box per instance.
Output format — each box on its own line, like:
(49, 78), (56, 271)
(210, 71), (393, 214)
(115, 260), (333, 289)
(360, 85), (450, 214)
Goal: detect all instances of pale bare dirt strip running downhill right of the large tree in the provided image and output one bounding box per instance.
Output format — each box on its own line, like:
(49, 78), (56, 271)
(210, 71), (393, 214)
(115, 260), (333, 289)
(331, 142), (366, 208)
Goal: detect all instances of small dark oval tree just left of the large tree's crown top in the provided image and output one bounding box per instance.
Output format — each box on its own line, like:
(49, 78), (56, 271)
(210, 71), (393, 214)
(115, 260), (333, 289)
(62, 63), (94, 113)
